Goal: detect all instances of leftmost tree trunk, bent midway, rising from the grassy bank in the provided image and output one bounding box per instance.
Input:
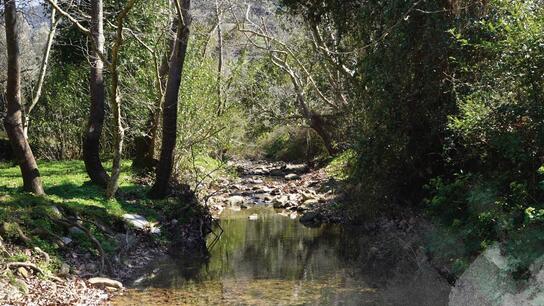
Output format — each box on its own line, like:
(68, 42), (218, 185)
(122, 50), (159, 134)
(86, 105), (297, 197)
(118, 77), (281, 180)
(4, 0), (44, 194)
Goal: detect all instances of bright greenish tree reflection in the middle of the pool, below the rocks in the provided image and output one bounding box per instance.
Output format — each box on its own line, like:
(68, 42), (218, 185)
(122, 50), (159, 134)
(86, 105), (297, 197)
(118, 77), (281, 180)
(209, 209), (344, 279)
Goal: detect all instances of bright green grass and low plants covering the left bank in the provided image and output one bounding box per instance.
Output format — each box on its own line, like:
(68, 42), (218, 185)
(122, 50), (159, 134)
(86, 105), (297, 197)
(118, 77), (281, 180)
(0, 161), (202, 271)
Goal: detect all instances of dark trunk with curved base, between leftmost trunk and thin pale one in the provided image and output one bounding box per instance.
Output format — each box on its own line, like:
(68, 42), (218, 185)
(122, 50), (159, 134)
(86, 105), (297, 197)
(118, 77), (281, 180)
(83, 0), (109, 188)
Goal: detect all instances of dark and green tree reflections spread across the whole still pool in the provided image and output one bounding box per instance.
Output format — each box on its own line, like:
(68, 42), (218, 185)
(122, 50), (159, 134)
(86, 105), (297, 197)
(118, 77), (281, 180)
(130, 210), (449, 305)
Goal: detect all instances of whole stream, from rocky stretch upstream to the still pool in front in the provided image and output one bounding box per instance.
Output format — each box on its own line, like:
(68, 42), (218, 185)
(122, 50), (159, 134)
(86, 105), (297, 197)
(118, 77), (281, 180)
(112, 164), (450, 306)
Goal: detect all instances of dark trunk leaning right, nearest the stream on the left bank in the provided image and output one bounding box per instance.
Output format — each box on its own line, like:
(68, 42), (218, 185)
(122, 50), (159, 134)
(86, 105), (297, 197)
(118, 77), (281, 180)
(149, 0), (191, 198)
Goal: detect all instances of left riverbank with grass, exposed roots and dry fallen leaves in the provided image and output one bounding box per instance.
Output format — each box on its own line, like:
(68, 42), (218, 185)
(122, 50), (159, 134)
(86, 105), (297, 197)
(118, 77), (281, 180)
(0, 161), (207, 305)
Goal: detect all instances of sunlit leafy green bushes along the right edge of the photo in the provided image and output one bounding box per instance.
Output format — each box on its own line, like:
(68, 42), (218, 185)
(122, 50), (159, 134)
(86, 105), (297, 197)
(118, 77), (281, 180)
(427, 0), (544, 272)
